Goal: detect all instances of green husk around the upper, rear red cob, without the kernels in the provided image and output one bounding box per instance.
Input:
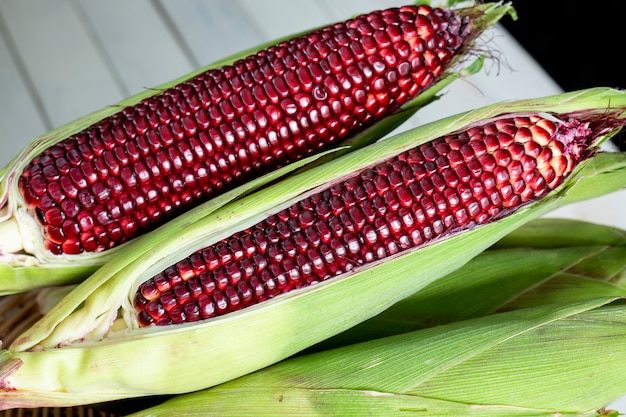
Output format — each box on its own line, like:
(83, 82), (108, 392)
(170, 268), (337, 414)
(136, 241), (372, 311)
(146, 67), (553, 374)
(0, 2), (513, 295)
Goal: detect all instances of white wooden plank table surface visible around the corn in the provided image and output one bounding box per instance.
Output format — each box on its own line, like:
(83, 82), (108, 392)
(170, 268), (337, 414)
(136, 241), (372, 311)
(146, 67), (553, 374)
(0, 0), (626, 411)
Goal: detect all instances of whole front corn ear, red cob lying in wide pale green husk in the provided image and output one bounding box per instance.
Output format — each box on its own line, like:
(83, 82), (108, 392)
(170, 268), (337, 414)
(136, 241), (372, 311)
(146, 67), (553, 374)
(0, 88), (626, 408)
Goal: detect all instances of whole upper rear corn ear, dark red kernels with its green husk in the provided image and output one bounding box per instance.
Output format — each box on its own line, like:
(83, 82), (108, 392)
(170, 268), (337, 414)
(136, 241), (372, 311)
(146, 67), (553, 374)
(0, 3), (512, 294)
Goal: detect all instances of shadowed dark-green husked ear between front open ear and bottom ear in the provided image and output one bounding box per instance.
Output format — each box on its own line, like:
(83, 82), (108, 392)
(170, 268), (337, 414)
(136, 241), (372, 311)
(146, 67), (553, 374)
(308, 218), (626, 350)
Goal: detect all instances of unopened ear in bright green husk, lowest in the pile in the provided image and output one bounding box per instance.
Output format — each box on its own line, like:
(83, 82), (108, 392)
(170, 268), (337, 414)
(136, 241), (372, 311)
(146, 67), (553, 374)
(125, 297), (626, 417)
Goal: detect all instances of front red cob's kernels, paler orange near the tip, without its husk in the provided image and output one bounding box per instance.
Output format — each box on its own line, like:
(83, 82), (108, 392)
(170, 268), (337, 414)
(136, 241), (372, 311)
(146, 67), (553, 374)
(134, 116), (591, 326)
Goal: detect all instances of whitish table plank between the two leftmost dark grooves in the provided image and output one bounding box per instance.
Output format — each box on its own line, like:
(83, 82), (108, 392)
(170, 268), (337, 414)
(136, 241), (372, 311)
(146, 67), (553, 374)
(0, 0), (123, 127)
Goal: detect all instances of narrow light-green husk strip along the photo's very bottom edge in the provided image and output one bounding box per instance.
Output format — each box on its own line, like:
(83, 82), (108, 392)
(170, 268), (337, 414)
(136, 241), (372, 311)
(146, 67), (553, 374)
(123, 387), (596, 417)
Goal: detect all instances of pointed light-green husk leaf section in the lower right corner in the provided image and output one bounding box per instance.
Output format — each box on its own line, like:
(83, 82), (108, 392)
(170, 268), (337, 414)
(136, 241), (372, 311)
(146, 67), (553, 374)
(404, 302), (626, 410)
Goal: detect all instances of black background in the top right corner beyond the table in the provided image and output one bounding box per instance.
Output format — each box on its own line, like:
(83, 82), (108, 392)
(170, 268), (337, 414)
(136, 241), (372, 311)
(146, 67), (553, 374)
(494, 0), (626, 151)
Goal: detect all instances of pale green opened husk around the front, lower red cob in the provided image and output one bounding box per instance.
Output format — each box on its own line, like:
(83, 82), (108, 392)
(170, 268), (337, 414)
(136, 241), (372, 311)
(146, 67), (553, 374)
(0, 89), (626, 408)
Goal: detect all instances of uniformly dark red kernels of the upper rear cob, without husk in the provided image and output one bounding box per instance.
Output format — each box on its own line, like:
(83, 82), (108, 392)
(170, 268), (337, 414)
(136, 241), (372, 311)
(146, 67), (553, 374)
(19, 6), (471, 254)
